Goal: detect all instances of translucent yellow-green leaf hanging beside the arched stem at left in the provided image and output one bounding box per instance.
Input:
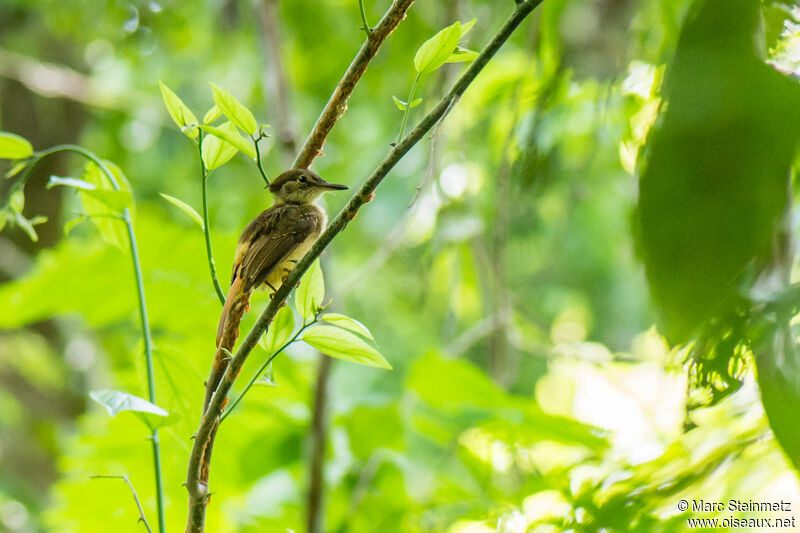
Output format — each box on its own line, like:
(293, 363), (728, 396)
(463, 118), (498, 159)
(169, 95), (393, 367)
(78, 161), (133, 250)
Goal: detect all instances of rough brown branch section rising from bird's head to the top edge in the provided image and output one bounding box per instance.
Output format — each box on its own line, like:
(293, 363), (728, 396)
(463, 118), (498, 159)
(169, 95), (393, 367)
(294, 0), (414, 168)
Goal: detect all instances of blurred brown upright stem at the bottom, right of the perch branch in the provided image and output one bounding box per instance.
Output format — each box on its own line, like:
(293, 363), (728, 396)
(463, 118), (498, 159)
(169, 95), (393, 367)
(306, 355), (333, 533)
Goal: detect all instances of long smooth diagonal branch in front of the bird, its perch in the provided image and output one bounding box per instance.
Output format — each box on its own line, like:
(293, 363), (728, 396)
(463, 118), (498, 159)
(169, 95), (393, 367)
(186, 0), (543, 533)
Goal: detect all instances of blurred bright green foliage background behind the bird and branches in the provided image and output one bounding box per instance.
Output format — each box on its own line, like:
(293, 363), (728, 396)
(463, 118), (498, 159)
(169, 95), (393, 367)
(0, 0), (800, 533)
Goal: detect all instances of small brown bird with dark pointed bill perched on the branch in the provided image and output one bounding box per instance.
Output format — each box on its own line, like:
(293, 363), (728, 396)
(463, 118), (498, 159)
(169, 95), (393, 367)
(217, 168), (347, 348)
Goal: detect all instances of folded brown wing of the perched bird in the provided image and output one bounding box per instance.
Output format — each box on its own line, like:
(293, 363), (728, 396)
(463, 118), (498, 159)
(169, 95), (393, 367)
(239, 207), (320, 292)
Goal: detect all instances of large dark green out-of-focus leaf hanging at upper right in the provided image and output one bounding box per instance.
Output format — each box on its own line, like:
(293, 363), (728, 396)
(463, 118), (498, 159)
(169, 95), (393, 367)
(638, 0), (800, 342)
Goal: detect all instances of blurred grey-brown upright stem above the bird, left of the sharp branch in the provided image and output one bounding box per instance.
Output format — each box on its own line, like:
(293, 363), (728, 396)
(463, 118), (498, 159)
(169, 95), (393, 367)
(258, 0), (297, 165)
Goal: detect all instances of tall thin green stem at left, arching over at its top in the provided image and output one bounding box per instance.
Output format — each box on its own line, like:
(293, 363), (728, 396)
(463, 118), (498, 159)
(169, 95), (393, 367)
(22, 144), (166, 533)
